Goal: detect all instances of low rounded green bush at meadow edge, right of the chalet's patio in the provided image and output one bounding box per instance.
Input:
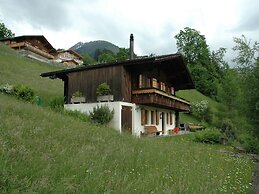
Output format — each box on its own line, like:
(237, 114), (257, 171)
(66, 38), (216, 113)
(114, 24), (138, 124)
(194, 129), (222, 144)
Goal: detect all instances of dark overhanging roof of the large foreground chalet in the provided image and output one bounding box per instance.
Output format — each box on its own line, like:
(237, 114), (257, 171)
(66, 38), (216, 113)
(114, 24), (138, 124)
(41, 53), (194, 90)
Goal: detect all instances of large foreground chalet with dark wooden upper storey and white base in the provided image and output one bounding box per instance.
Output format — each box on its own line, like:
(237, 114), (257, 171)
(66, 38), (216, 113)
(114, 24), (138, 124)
(41, 54), (194, 136)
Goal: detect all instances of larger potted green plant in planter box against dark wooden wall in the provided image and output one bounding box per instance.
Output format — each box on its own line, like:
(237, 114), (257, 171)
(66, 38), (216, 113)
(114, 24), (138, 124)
(96, 82), (113, 102)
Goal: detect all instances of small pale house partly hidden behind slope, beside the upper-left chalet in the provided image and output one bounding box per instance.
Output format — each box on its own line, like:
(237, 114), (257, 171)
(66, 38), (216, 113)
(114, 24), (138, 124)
(54, 50), (83, 68)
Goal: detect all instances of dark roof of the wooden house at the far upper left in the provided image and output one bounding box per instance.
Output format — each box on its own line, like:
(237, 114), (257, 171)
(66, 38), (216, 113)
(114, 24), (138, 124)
(0, 35), (56, 53)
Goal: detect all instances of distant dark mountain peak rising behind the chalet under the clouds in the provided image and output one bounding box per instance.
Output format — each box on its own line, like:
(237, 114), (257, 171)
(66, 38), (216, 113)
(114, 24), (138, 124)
(70, 40), (119, 58)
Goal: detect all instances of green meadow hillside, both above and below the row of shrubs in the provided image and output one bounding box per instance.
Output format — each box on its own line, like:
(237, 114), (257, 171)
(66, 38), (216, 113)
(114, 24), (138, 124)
(0, 45), (254, 193)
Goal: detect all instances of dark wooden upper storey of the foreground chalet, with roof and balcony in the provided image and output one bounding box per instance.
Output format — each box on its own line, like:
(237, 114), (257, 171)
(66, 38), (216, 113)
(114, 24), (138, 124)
(41, 54), (194, 112)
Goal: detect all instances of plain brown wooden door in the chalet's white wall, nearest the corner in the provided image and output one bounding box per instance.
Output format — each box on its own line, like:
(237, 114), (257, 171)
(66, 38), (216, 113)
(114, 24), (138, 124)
(121, 106), (132, 133)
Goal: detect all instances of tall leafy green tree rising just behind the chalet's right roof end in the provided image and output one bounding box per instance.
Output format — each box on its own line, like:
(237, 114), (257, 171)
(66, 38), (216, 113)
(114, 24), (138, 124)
(175, 27), (225, 98)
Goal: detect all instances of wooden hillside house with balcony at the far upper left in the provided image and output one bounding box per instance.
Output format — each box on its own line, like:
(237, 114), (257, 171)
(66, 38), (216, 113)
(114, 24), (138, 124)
(0, 35), (56, 62)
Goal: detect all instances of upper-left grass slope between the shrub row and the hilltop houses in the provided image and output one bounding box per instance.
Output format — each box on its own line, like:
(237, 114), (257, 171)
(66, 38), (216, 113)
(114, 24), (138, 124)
(0, 43), (63, 104)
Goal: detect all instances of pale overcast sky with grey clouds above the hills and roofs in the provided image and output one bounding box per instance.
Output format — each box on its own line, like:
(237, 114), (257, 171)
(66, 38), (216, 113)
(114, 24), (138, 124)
(0, 0), (259, 60)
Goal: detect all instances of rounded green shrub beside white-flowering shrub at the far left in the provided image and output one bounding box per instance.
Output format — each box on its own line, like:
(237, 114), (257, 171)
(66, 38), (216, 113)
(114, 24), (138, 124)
(13, 84), (34, 102)
